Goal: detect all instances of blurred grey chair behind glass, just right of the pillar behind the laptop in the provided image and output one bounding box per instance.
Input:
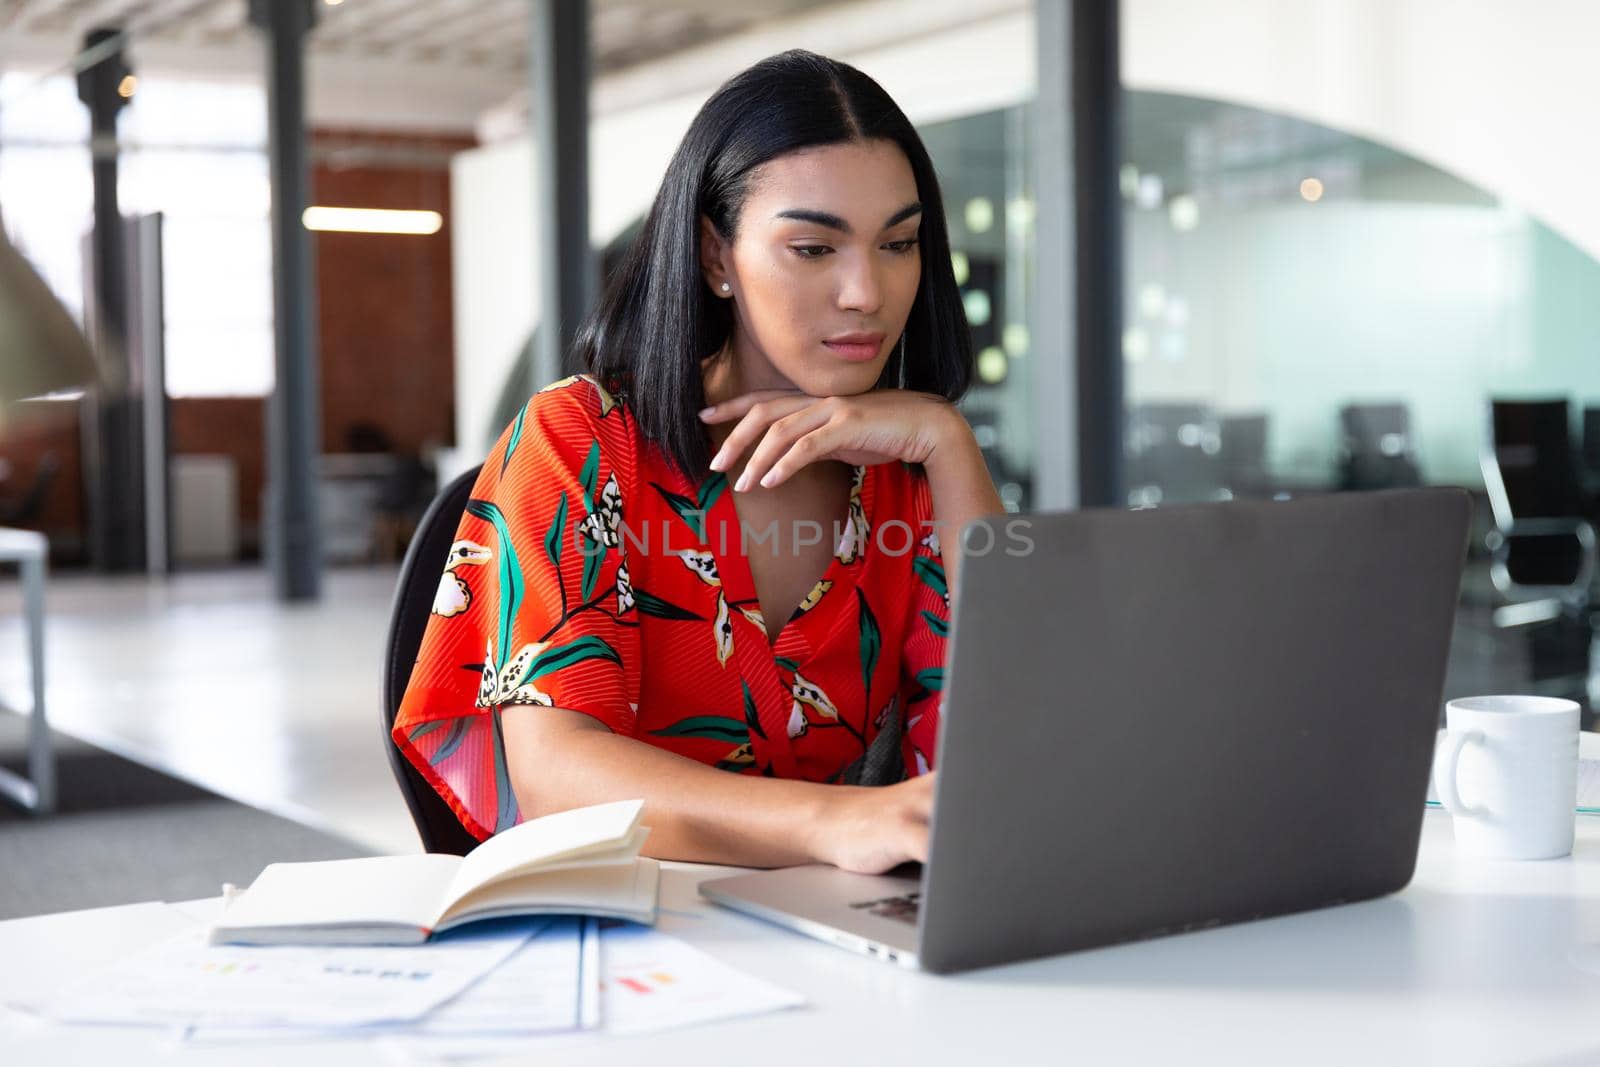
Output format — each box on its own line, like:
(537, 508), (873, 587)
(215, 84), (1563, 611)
(1126, 403), (1230, 507)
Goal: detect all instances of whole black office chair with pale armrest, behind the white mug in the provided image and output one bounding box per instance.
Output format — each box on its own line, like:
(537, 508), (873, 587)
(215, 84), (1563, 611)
(1483, 400), (1597, 625)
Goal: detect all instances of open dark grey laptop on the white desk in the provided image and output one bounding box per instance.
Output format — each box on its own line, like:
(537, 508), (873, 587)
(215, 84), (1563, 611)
(701, 490), (1470, 973)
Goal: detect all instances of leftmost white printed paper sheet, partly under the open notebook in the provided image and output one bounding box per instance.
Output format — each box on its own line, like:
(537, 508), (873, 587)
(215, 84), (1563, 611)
(48, 920), (538, 1029)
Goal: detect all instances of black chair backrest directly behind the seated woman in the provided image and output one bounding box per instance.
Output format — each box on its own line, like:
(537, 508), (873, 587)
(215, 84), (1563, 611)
(382, 467), (480, 856)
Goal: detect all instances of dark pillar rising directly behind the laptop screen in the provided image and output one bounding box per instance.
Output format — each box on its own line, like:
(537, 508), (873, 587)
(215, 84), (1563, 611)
(1069, 0), (1128, 507)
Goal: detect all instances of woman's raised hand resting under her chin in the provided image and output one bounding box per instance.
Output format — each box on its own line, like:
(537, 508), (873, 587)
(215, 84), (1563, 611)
(701, 389), (966, 493)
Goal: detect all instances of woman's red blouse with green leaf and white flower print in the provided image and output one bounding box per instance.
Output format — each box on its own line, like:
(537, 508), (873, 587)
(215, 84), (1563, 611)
(394, 374), (949, 838)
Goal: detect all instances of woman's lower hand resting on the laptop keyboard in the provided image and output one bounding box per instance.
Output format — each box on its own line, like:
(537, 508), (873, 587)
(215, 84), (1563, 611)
(811, 774), (933, 875)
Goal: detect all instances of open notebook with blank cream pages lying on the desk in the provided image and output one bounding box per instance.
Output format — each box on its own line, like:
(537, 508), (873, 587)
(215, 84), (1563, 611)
(210, 800), (659, 945)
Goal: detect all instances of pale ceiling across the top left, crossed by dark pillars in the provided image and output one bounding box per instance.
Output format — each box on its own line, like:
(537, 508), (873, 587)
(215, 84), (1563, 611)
(0, 0), (853, 133)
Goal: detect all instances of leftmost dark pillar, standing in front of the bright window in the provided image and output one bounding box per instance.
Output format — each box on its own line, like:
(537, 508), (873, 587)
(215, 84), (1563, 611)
(78, 29), (146, 571)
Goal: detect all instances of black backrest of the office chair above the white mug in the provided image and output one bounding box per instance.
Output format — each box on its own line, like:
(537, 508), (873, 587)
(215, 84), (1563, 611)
(1490, 400), (1587, 526)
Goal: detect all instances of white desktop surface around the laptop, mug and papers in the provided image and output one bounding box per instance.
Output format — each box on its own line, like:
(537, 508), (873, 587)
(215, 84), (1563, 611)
(9, 811), (1600, 1067)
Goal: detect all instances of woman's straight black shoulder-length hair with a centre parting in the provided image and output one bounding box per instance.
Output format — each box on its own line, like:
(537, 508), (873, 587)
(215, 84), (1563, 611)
(573, 50), (973, 480)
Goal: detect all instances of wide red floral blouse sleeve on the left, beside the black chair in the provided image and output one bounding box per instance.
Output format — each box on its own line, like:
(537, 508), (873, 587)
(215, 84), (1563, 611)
(394, 378), (638, 838)
